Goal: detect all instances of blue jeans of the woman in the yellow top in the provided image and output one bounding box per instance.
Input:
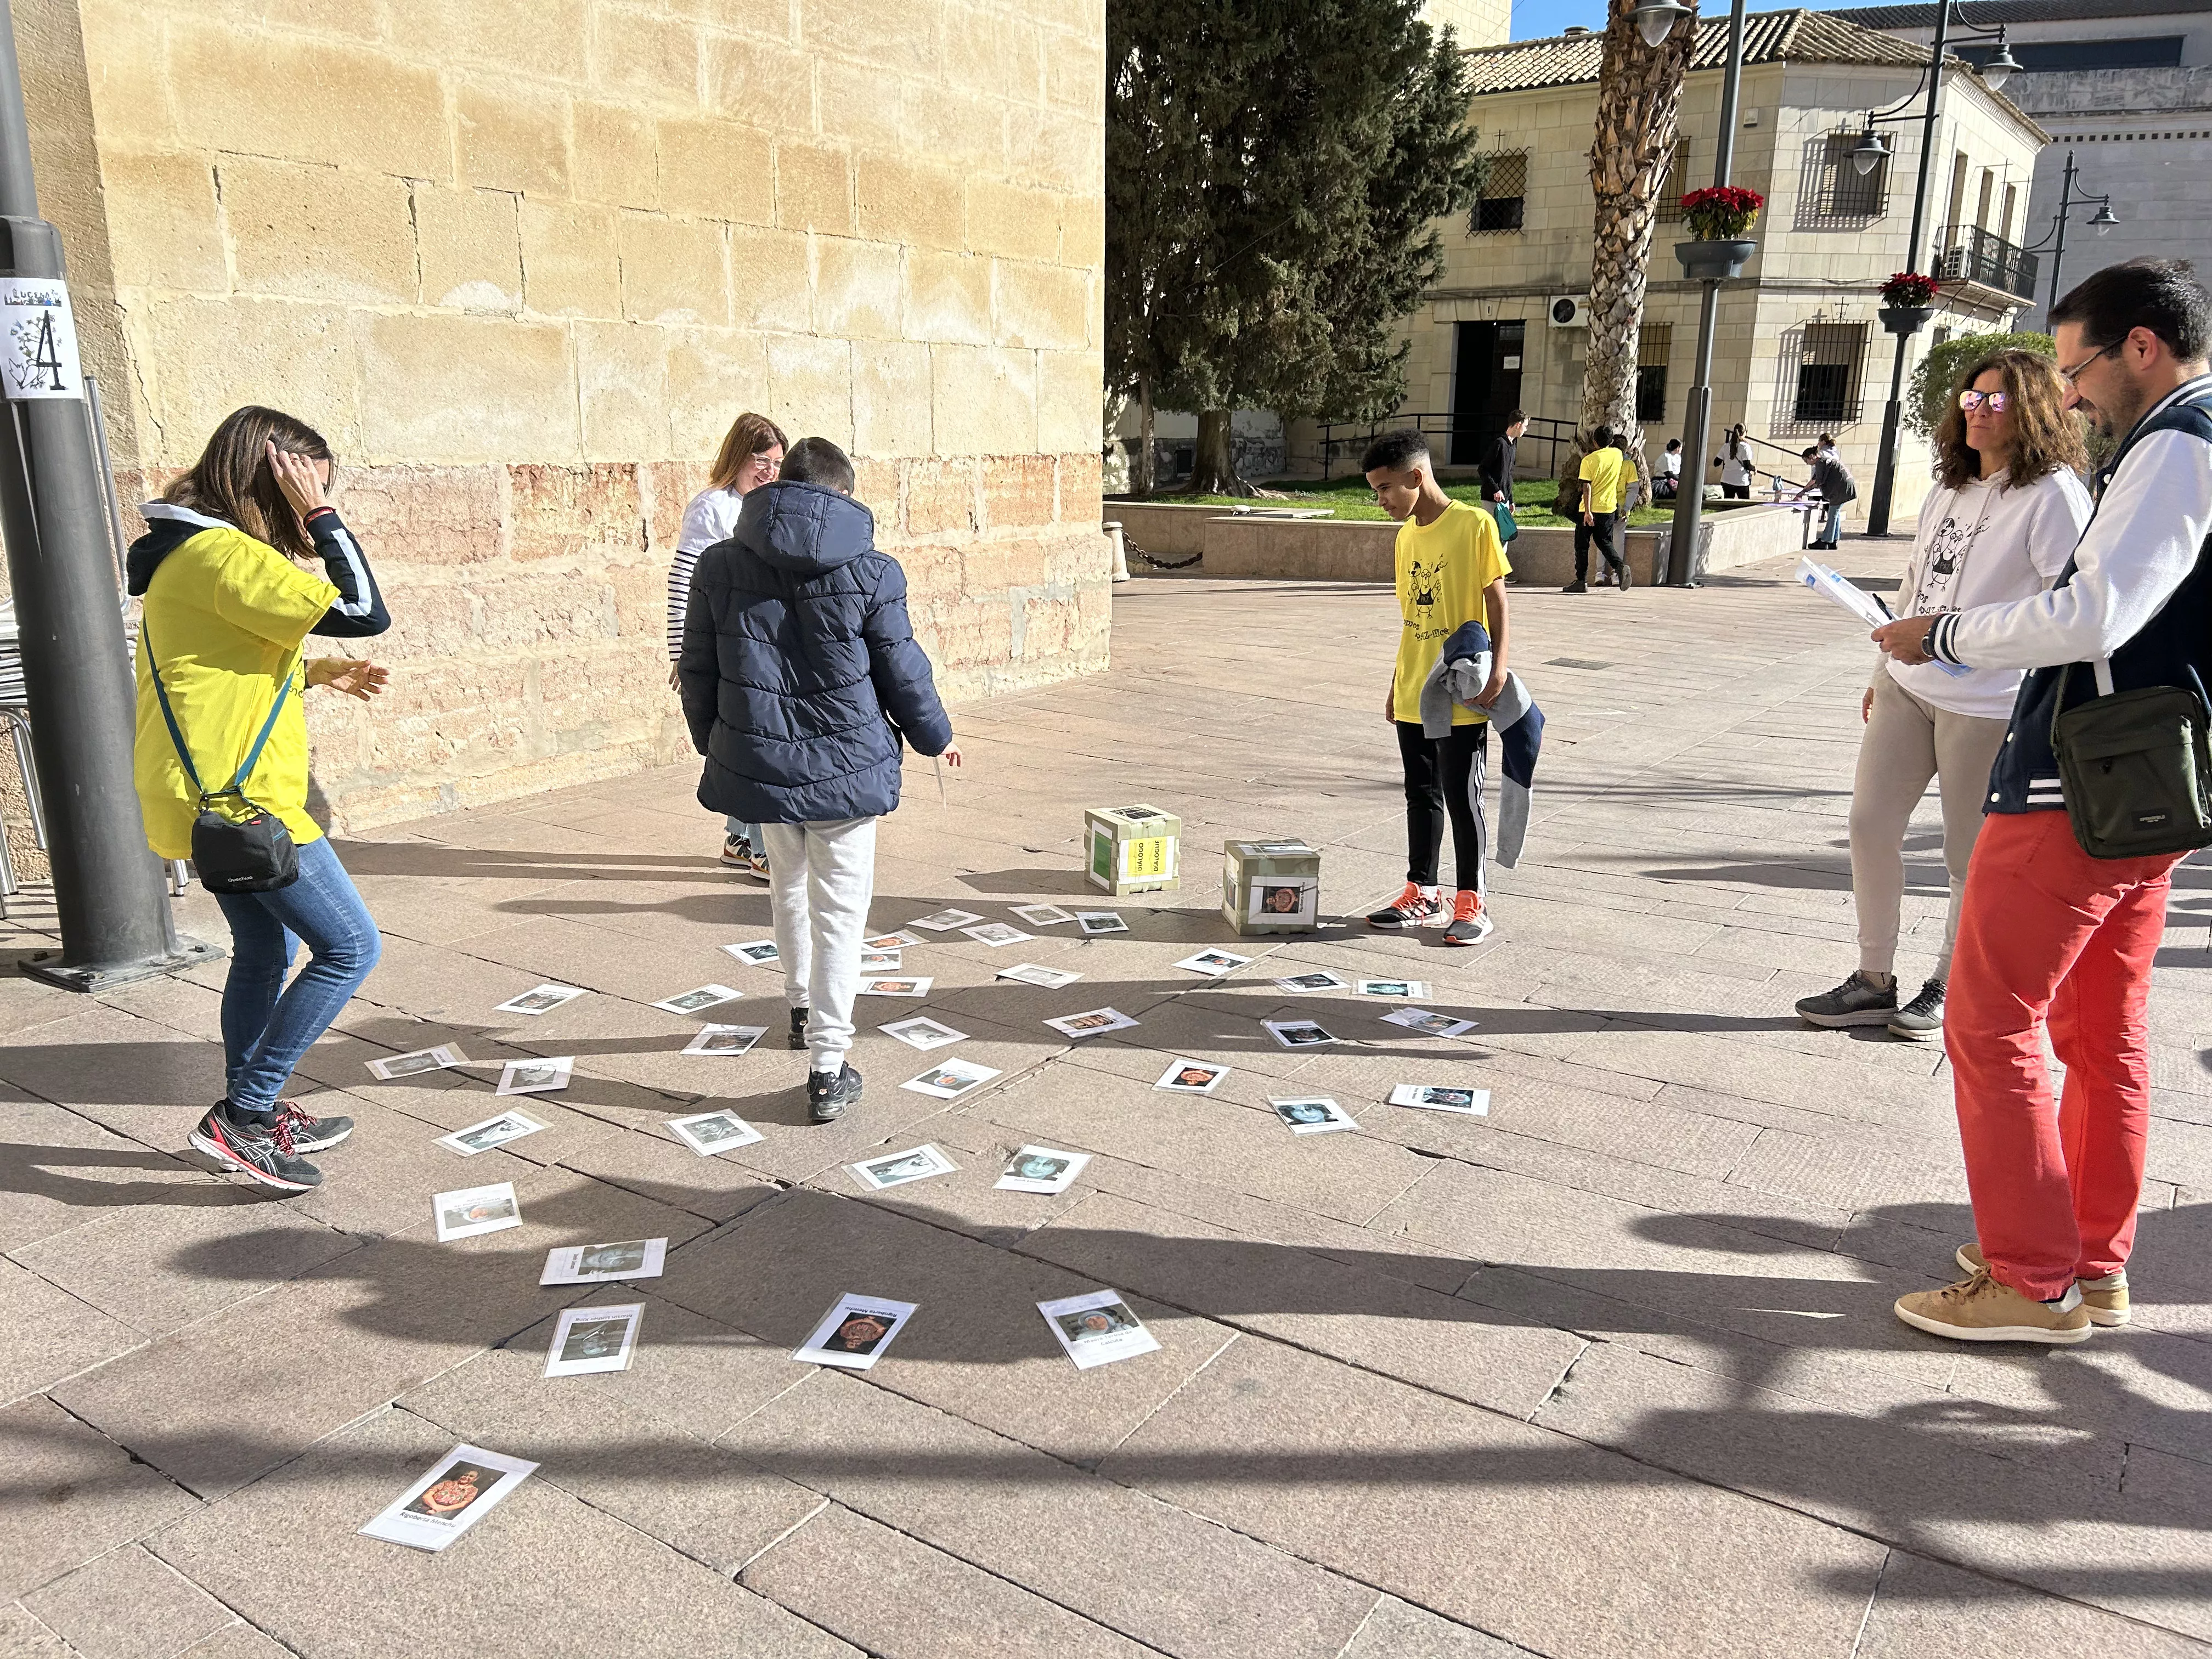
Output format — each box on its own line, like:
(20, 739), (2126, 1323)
(215, 836), (385, 1113)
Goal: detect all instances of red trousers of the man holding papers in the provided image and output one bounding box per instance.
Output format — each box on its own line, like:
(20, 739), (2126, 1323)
(1944, 812), (2181, 1301)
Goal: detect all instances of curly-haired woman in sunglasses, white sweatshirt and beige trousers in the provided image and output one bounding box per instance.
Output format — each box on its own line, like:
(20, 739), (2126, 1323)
(1796, 352), (2090, 1042)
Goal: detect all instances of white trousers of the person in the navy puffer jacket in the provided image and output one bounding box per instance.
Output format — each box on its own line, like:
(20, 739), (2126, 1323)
(761, 819), (876, 1070)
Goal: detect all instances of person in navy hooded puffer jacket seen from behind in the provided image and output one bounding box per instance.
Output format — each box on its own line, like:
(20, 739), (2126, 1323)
(677, 438), (960, 1124)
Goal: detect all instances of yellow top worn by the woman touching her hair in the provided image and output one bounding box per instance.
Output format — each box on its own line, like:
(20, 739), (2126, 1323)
(133, 524), (338, 858)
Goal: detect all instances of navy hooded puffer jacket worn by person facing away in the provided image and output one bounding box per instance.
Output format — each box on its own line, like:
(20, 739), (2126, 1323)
(677, 482), (953, 823)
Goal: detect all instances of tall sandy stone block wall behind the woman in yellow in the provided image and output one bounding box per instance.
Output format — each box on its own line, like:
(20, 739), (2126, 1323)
(15, 0), (1110, 827)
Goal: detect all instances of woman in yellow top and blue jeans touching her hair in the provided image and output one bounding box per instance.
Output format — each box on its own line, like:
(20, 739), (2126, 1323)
(126, 407), (392, 1192)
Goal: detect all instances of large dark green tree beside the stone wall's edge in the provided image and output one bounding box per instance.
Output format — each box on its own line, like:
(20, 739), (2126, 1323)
(1106, 0), (1477, 493)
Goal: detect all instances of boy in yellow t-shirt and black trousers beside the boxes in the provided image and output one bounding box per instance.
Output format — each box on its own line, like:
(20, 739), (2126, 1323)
(1361, 431), (1513, 945)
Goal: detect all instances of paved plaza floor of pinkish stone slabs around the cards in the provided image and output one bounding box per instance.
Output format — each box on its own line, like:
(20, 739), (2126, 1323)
(0, 555), (2212, 1659)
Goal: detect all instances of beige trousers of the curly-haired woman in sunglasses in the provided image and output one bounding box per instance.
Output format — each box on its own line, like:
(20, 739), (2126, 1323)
(1852, 668), (2008, 980)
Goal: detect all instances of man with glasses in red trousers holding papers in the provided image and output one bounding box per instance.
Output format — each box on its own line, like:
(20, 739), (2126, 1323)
(1874, 259), (2212, 1342)
